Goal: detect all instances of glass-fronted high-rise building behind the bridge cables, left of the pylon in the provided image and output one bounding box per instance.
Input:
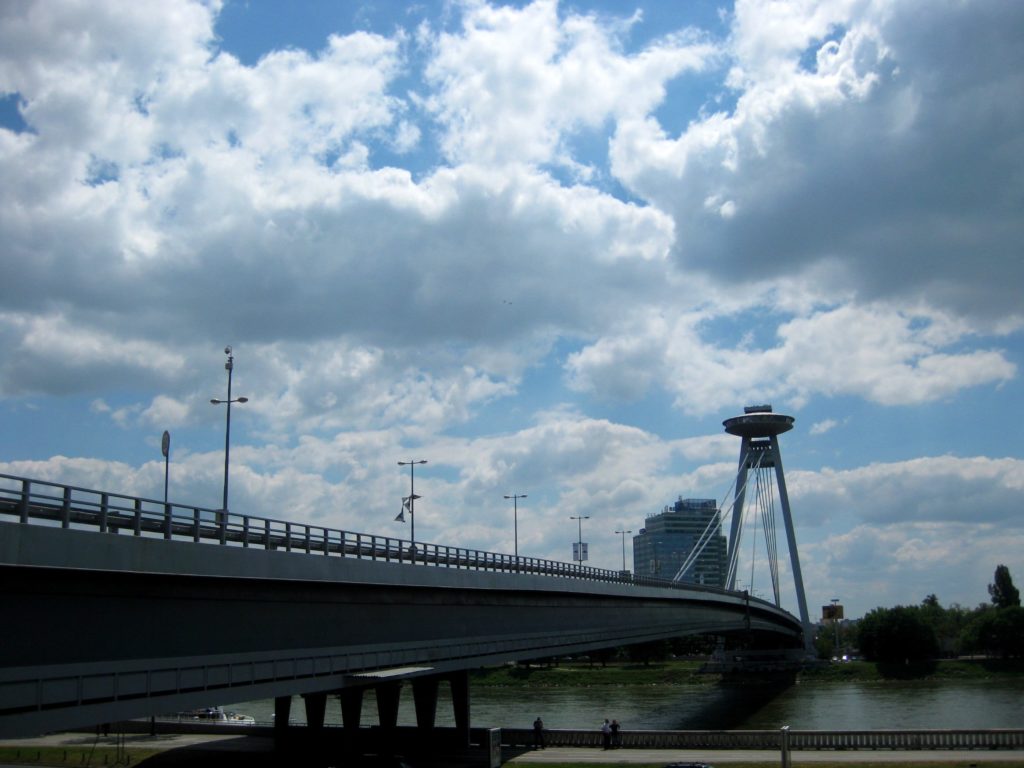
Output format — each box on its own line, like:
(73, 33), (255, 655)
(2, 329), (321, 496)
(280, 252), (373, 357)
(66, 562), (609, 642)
(633, 497), (726, 587)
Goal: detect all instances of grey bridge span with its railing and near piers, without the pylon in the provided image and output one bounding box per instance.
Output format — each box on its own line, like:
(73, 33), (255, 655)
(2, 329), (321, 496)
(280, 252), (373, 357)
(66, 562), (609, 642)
(0, 474), (802, 739)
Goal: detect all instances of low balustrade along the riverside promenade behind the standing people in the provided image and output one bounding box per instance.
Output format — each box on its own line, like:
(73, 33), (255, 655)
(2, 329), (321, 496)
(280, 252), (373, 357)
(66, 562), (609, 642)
(502, 728), (1024, 751)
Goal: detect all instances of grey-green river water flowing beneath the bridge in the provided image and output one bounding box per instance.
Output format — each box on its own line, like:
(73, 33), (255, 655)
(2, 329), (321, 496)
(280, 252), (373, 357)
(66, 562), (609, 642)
(235, 679), (1024, 730)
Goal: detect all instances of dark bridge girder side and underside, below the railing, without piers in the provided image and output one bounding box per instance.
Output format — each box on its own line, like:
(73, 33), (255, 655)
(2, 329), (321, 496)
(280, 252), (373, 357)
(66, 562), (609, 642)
(0, 523), (800, 736)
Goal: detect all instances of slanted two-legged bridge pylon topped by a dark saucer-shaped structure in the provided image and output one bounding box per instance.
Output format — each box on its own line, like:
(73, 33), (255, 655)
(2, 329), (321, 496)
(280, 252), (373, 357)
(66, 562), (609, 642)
(722, 404), (814, 651)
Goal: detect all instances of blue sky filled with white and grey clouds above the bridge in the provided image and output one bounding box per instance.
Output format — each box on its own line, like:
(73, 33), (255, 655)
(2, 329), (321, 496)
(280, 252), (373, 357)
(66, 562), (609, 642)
(0, 0), (1024, 616)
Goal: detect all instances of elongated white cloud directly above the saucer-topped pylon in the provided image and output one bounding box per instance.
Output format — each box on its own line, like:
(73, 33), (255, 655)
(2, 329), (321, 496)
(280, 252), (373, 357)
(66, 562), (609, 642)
(566, 305), (1017, 414)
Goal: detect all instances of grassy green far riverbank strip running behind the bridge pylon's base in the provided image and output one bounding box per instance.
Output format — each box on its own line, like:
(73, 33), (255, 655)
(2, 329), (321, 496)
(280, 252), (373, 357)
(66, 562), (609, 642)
(470, 658), (1024, 688)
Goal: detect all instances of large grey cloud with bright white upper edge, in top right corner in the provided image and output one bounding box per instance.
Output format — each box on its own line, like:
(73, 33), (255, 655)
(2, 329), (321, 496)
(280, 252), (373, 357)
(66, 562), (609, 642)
(612, 1), (1024, 324)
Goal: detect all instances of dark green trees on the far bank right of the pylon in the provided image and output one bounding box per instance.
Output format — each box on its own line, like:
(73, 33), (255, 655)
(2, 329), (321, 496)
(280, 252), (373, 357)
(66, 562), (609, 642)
(839, 564), (1024, 663)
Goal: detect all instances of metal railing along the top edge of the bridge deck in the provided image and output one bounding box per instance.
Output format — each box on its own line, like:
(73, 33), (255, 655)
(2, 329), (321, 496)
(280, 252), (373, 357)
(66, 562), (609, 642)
(0, 473), (741, 602)
